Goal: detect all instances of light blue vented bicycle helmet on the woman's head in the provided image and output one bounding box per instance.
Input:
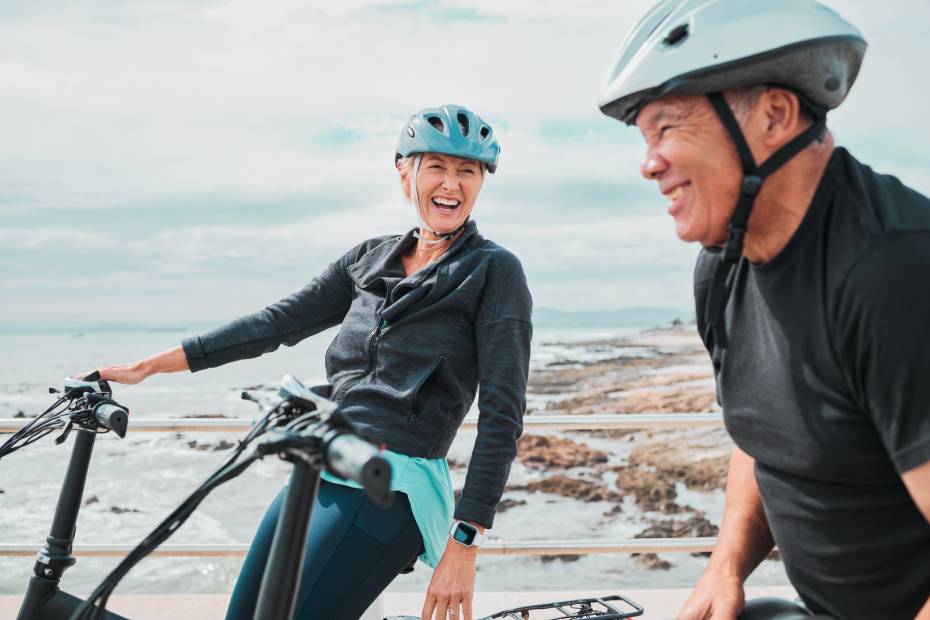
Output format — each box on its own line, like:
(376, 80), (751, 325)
(394, 104), (501, 173)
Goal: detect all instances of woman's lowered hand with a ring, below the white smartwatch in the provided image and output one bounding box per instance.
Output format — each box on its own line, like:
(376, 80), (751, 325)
(420, 539), (478, 620)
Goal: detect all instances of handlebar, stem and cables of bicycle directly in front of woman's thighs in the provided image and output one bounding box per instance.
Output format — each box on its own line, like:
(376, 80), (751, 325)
(67, 375), (391, 620)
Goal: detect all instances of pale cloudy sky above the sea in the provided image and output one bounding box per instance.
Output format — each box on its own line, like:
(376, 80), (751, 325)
(0, 0), (930, 327)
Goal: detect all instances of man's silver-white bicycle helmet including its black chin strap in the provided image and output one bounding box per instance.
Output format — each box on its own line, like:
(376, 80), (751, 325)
(599, 0), (866, 369)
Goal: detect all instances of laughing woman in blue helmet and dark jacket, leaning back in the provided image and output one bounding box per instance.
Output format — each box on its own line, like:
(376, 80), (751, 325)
(91, 105), (532, 620)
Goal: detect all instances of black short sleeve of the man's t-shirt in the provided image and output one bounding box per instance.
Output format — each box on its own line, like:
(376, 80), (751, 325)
(835, 232), (930, 473)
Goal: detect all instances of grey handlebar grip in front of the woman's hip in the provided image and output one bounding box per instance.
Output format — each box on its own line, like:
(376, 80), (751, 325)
(326, 433), (391, 506)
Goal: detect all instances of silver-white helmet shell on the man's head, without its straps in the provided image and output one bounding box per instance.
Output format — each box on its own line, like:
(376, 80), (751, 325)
(600, 0), (866, 124)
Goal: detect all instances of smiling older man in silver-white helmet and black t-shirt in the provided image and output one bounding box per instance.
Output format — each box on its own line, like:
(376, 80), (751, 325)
(601, 0), (930, 620)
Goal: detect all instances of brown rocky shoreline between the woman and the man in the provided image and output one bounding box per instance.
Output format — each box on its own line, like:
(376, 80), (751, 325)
(482, 326), (732, 570)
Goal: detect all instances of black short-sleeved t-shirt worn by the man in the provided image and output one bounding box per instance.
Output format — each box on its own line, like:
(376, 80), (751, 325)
(695, 149), (930, 619)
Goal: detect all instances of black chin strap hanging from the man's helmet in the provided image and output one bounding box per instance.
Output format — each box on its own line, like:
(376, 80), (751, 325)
(703, 93), (827, 369)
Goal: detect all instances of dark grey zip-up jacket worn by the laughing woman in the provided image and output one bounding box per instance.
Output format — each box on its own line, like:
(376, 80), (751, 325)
(183, 221), (532, 528)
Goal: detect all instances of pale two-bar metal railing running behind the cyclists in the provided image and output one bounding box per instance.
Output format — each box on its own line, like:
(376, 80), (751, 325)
(0, 413), (723, 557)
